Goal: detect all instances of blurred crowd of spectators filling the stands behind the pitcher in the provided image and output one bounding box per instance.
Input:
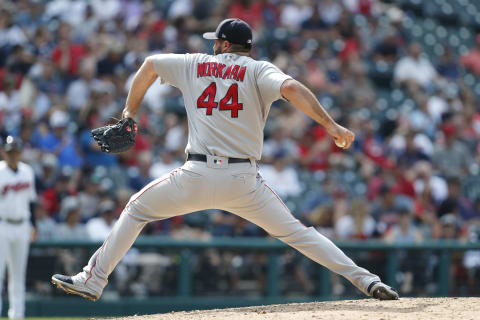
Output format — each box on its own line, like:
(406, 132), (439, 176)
(0, 0), (480, 298)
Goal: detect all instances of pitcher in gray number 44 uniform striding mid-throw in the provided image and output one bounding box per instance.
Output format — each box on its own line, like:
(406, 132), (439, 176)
(52, 19), (398, 300)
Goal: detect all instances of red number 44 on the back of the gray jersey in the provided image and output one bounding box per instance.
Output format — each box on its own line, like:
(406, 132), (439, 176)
(197, 82), (243, 118)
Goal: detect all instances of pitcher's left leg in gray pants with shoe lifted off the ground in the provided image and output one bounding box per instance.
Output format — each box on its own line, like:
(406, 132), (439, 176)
(52, 168), (209, 298)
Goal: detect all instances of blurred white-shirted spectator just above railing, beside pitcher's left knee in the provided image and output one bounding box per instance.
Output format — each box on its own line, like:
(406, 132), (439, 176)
(85, 199), (116, 241)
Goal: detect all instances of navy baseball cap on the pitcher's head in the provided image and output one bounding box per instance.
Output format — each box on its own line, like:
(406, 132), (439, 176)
(203, 18), (253, 48)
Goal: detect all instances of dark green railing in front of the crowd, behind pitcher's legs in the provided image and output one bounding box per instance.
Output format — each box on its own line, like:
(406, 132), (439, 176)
(3, 237), (480, 316)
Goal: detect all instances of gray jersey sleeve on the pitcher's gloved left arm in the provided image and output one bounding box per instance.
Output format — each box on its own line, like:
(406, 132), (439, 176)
(151, 53), (188, 89)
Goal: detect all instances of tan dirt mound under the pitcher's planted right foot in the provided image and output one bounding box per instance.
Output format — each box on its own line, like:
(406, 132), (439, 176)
(105, 298), (480, 320)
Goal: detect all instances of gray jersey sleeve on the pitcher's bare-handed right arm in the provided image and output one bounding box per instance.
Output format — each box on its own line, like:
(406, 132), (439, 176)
(257, 61), (292, 104)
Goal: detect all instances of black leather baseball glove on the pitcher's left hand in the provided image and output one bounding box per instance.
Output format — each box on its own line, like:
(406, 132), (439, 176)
(92, 118), (137, 153)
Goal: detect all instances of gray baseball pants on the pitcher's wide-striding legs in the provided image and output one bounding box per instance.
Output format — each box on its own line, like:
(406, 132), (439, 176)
(76, 156), (380, 295)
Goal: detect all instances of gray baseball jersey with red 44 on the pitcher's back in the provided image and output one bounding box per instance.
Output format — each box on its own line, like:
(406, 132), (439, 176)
(152, 53), (291, 160)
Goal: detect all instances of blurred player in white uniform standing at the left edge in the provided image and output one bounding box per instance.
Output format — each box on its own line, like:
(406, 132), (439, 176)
(0, 136), (36, 319)
